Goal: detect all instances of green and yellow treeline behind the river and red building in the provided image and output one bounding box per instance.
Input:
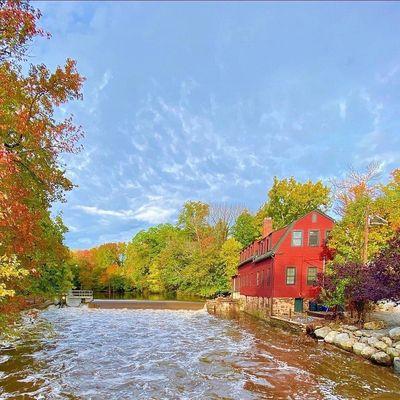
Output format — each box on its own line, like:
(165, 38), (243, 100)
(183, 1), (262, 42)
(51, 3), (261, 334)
(71, 165), (400, 296)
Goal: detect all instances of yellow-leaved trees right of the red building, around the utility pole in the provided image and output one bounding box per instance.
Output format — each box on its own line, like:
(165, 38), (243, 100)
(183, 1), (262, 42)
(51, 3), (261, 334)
(329, 164), (400, 264)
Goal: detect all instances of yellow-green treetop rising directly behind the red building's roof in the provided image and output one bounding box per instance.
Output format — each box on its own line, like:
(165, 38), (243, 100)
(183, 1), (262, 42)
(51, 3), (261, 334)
(256, 177), (330, 229)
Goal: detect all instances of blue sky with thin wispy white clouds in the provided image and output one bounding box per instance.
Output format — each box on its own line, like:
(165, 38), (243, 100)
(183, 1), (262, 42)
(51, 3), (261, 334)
(31, 1), (400, 249)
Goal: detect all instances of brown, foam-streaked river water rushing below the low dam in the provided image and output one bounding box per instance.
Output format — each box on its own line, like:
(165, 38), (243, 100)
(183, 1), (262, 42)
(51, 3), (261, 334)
(0, 308), (400, 400)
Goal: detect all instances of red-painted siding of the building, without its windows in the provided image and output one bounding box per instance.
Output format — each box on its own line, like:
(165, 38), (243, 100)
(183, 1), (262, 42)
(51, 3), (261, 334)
(238, 212), (334, 298)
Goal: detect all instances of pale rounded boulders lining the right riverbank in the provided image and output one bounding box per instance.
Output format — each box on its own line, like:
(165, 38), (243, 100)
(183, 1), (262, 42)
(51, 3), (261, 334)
(313, 323), (400, 374)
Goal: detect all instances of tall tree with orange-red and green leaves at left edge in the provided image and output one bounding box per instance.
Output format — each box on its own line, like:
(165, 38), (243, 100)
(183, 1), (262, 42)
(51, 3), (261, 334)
(0, 0), (83, 296)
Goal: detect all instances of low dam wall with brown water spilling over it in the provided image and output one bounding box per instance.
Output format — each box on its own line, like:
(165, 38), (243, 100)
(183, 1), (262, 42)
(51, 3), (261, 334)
(89, 299), (205, 311)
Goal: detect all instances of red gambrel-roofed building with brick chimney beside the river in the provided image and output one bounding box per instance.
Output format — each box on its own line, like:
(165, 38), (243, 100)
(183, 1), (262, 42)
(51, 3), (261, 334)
(233, 210), (334, 314)
